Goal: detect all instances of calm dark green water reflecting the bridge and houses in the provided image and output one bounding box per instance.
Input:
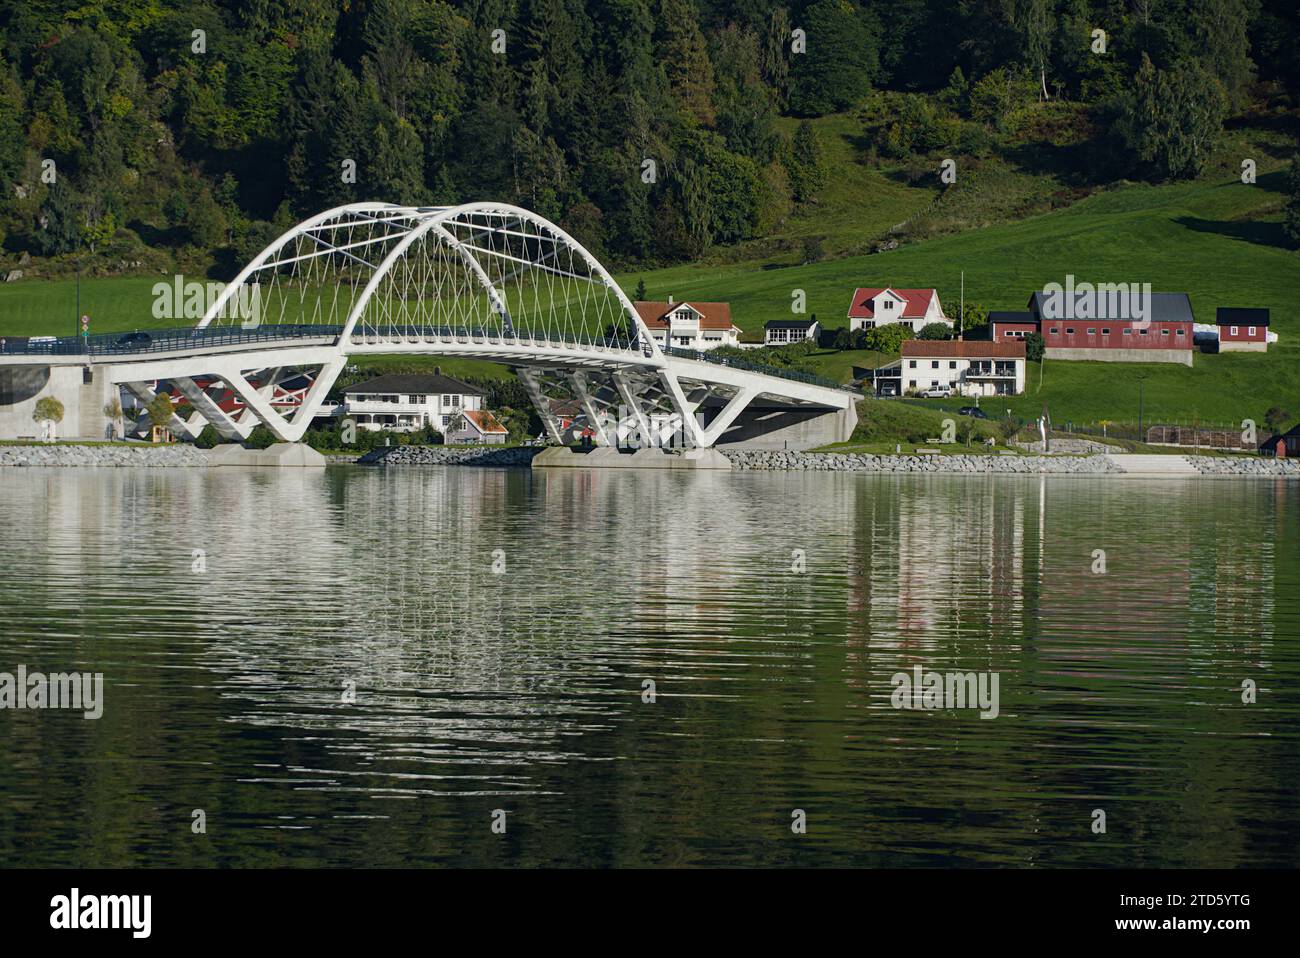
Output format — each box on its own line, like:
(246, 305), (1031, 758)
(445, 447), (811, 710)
(0, 467), (1300, 867)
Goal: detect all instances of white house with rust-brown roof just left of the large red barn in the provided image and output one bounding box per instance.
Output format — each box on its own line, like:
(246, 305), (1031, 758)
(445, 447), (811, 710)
(875, 339), (1024, 396)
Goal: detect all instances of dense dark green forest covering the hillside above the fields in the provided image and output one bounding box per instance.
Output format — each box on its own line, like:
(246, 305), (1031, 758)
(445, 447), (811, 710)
(0, 0), (1300, 276)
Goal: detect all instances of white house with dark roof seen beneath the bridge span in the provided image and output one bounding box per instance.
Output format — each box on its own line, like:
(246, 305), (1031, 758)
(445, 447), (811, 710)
(333, 369), (495, 432)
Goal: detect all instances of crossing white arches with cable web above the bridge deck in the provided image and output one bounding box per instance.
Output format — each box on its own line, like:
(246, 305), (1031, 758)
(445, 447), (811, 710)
(196, 203), (664, 365)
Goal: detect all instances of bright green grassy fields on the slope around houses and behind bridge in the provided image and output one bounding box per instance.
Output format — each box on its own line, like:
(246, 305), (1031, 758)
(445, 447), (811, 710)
(0, 124), (1300, 424)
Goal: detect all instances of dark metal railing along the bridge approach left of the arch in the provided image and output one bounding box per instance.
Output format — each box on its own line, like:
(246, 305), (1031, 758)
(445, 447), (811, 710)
(0, 325), (343, 359)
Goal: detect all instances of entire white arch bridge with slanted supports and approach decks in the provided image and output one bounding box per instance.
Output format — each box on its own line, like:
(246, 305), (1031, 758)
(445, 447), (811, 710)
(4, 203), (857, 448)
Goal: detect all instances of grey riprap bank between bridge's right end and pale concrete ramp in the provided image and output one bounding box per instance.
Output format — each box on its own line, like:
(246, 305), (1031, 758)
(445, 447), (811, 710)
(722, 448), (1121, 476)
